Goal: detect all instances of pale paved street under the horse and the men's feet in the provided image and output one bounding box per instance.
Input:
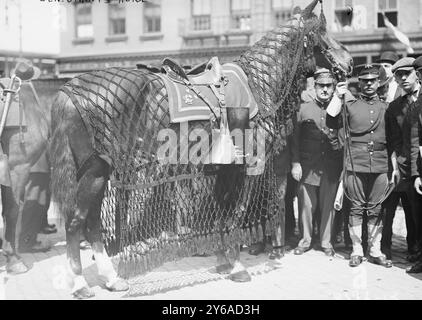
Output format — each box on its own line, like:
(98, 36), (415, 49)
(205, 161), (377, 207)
(0, 202), (422, 300)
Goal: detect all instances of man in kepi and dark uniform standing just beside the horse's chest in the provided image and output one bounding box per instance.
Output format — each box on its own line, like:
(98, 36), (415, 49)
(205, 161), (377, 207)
(291, 69), (342, 256)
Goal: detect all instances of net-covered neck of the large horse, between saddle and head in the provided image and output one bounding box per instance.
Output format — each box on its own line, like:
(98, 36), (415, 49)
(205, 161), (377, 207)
(237, 14), (325, 148)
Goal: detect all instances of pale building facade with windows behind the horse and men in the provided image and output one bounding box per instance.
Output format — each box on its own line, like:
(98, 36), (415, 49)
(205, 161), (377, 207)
(58, 0), (422, 76)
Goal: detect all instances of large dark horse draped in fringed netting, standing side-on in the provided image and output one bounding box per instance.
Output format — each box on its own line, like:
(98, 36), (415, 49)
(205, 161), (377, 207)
(50, 1), (352, 298)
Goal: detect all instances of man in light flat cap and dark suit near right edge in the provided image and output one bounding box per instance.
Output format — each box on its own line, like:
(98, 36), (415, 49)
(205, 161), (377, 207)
(381, 57), (422, 262)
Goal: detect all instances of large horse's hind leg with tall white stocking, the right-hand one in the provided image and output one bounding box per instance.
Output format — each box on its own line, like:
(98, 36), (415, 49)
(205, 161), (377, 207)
(74, 156), (129, 291)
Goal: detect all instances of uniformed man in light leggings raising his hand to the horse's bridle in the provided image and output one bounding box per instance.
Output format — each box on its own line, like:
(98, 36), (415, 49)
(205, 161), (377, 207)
(327, 65), (392, 267)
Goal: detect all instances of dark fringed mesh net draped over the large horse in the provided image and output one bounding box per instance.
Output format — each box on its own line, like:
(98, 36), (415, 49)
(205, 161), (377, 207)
(58, 13), (324, 277)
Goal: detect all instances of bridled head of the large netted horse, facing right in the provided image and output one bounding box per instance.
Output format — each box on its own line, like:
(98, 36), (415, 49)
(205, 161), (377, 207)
(301, 0), (353, 78)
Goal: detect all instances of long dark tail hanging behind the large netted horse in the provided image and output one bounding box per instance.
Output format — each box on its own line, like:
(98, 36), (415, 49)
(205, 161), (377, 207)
(49, 91), (77, 221)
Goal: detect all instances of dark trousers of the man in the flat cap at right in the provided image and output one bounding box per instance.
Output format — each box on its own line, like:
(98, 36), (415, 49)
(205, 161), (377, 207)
(381, 180), (421, 254)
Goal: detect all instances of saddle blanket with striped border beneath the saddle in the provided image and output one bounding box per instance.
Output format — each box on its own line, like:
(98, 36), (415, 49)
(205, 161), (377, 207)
(157, 63), (258, 123)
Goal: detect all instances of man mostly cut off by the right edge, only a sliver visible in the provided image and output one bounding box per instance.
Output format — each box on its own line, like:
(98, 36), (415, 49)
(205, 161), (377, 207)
(406, 56), (422, 273)
